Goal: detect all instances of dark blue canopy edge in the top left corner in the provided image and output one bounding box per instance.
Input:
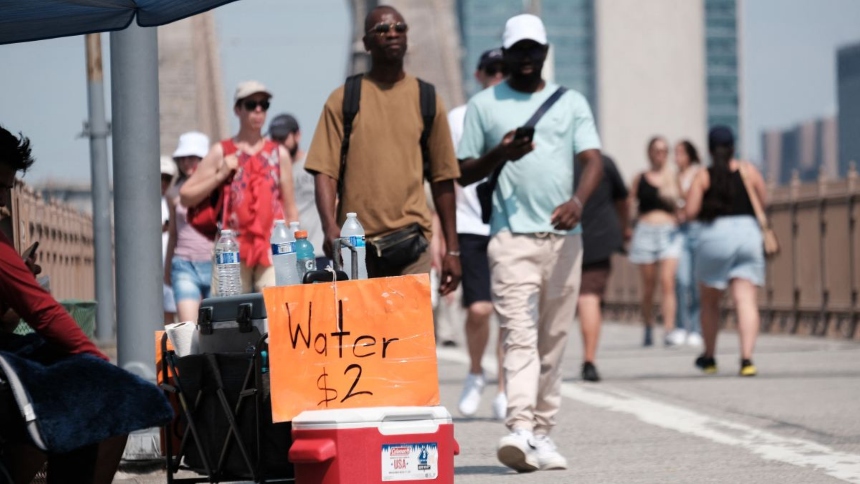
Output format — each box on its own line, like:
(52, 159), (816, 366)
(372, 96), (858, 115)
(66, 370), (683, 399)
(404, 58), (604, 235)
(0, 0), (235, 44)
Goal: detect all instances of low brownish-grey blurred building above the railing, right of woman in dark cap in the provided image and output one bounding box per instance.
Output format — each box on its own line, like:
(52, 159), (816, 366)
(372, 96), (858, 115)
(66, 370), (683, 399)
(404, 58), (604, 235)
(761, 116), (836, 185)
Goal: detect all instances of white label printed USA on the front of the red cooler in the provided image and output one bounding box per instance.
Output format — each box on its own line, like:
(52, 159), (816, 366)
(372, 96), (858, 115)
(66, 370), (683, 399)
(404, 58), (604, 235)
(382, 442), (439, 481)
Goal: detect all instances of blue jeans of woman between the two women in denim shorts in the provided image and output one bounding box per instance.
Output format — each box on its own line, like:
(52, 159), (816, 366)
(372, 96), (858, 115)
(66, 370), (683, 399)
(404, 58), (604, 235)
(675, 222), (702, 333)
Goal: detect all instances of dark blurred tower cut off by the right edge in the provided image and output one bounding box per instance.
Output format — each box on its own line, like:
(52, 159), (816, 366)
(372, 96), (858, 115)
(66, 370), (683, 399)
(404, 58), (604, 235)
(836, 43), (860, 176)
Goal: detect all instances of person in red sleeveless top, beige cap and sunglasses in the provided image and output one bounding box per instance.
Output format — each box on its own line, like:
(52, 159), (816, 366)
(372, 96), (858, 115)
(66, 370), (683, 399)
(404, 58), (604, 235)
(179, 81), (298, 293)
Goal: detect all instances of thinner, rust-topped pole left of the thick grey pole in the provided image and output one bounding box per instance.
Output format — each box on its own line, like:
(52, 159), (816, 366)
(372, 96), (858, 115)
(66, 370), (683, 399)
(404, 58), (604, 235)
(85, 34), (114, 343)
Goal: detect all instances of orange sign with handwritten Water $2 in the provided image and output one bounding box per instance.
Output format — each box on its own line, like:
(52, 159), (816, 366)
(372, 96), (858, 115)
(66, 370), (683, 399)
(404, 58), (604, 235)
(263, 275), (439, 422)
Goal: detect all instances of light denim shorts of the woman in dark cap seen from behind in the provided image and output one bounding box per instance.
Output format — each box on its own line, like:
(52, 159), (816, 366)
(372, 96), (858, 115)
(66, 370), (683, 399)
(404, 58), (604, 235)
(694, 215), (765, 289)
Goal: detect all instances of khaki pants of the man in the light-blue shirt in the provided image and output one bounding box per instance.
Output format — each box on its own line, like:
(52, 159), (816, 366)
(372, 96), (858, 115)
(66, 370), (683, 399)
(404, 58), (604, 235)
(487, 232), (582, 434)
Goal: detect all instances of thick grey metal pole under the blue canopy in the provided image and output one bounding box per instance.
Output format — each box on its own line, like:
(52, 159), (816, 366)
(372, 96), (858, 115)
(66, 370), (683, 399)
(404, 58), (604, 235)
(110, 22), (164, 381)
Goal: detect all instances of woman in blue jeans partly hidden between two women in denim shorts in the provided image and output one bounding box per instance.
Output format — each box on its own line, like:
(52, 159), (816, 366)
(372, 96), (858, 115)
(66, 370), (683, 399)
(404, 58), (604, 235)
(675, 140), (702, 347)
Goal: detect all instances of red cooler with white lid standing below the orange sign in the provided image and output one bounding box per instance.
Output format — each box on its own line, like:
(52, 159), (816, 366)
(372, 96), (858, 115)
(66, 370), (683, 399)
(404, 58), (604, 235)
(290, 407), (460, 484)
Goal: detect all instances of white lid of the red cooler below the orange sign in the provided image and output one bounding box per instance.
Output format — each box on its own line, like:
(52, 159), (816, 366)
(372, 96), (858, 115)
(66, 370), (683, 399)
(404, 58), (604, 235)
(293, 406), (451, 429)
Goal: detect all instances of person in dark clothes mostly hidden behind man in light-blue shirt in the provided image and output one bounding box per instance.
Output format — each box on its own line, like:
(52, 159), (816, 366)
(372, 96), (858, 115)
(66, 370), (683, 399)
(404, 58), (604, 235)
(575, 155), (631, 382)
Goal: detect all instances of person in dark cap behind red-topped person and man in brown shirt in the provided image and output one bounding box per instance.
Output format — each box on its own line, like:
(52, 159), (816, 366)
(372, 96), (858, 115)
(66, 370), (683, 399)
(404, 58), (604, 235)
(269, 114), (331, 269)
